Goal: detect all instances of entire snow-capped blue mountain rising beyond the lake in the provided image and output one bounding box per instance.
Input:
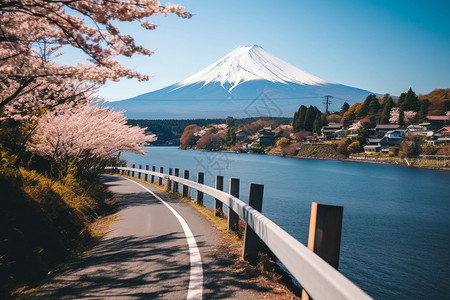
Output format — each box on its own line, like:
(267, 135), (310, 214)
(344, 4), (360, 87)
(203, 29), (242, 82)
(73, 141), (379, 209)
(106, 45), (378, 119)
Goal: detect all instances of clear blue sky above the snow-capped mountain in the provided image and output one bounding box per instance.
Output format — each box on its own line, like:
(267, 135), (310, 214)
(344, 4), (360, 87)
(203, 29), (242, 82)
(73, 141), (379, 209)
(93, 0), (450, 100)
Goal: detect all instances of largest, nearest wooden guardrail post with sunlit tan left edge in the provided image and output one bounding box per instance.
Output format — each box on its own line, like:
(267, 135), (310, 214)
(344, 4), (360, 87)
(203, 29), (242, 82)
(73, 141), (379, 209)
(302, 202), (344, 300)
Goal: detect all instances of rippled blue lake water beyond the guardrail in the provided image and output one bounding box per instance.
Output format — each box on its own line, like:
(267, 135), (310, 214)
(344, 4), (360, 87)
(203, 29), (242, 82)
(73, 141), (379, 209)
(123, 147), (450, 299)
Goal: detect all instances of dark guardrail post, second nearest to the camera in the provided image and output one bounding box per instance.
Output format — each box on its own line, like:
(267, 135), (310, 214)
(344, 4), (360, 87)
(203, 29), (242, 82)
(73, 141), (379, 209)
(242, 183), (264, 263)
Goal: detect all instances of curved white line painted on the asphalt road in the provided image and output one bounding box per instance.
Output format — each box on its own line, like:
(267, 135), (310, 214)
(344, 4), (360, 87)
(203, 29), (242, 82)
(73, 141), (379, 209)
(125, 178), (203, 300)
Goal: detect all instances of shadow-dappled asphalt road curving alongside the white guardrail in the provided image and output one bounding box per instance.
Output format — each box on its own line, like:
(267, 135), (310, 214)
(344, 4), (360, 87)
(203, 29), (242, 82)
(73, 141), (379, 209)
(32, 176), (266, 299)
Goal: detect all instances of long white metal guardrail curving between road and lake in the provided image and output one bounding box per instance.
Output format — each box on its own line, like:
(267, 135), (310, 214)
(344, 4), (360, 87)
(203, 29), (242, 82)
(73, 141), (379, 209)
(106, 167), (372, 300)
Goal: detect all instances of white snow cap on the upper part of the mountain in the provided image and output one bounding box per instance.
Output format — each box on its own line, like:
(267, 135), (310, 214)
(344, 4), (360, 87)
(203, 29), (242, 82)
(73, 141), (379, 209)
(176, 45), (329, 92)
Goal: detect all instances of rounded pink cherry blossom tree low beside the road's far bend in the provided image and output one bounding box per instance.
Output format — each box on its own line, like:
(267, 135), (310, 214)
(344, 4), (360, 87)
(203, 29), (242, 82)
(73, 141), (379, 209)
(27, 101), (156, 176)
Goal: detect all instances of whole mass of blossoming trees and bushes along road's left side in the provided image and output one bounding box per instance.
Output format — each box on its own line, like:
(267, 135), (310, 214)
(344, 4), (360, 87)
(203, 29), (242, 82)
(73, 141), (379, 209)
(0, 0), (191, 298)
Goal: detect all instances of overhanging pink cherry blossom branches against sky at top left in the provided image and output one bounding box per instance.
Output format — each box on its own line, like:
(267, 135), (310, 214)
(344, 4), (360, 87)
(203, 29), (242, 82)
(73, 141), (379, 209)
(0, 0), (191, 108)
